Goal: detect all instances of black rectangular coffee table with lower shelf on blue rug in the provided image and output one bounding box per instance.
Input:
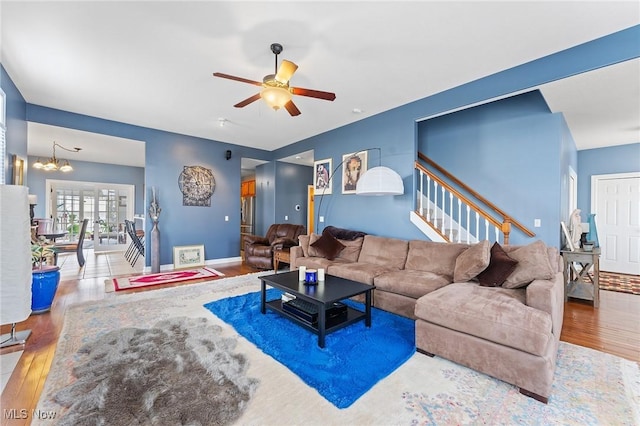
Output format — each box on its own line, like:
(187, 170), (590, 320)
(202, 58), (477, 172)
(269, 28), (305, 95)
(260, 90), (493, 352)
(260, 270), (376, 348)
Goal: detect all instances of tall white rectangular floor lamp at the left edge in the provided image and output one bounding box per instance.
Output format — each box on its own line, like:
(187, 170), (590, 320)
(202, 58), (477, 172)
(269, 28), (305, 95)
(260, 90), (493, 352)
(0, 185), (31, 348)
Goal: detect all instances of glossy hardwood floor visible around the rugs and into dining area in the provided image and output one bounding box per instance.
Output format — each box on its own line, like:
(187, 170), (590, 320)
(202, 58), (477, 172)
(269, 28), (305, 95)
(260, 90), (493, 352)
(0, 253), (640, 426)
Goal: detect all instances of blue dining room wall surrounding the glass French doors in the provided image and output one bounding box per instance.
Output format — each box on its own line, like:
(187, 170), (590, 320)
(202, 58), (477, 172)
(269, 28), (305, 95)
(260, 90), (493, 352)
(27, 157), (145, 220)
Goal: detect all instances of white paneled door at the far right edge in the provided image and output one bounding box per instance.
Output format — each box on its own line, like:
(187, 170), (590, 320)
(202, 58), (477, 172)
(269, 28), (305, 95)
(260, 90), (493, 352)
(591, 173), (640, 275)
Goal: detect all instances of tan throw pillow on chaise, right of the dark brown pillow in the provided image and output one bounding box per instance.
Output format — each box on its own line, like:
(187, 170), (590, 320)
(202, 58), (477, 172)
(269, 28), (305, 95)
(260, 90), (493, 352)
(502, 241), (555, 288)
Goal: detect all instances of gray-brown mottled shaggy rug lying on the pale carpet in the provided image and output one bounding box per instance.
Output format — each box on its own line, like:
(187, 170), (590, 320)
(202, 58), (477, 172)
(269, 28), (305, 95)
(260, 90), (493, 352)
(54, 317), (258, 425)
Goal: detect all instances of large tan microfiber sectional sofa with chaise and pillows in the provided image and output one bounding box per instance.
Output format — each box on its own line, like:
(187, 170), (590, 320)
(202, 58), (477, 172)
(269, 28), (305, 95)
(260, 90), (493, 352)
(291, 227), (564, 402)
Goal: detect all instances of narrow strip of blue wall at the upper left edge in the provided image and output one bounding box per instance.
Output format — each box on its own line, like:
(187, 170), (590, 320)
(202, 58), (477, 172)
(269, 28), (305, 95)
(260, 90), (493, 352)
(0, 64), (28, 184)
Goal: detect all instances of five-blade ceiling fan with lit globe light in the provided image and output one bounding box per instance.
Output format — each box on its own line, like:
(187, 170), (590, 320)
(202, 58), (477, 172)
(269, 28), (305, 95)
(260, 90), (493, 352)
(213, 43), (336, 116)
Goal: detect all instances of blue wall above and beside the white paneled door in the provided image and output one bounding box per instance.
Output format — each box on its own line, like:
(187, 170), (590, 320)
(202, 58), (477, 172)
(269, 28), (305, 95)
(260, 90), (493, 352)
(577, 143), (640, 216)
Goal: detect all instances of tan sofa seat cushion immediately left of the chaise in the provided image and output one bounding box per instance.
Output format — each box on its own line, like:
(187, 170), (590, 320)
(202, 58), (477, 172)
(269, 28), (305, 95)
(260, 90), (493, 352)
(373, 269), (451, 299)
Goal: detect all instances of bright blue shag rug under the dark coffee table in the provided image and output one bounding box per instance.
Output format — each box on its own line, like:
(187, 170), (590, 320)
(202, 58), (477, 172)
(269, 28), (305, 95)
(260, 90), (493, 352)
(204, 289), (415, 408)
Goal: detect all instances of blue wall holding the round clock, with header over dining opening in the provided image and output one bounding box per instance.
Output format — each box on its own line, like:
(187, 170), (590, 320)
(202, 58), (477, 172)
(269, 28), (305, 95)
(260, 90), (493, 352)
(27, 104), (272, 266)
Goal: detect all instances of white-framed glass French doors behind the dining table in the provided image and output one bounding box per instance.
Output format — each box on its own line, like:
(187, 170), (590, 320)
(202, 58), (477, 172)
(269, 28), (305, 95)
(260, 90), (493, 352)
(46, 179), (135, 252)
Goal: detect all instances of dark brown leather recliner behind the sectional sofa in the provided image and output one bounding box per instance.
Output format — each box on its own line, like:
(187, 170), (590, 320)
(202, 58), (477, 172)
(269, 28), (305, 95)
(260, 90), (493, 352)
(242, 223), (306, 269)
